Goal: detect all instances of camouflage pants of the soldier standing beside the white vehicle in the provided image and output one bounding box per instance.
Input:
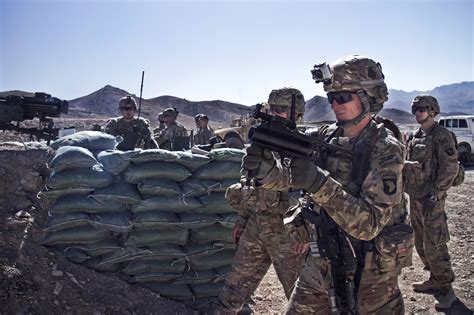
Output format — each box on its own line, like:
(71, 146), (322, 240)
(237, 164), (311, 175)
(410, 198), (454, 285)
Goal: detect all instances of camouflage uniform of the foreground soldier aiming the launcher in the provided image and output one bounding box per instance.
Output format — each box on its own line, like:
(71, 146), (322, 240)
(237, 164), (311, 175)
(263, 122), (407, 314)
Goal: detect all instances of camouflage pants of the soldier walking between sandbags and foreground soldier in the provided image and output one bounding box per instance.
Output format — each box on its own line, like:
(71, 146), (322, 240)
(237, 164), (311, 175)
(219, 214), (305, 310)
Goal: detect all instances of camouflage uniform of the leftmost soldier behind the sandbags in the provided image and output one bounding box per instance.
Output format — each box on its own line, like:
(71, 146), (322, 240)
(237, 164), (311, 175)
(104, 117), (158, 151)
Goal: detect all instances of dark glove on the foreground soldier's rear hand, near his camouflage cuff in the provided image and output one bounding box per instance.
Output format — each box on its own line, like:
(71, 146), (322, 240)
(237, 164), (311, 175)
(290, 158), (329, 193)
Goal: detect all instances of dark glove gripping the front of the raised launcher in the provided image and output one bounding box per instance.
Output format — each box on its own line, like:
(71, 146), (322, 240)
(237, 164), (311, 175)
(242, 143), (276, 180)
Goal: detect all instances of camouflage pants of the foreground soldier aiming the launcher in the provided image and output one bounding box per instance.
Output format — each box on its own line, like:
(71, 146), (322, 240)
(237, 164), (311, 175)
(286, 252), (404, 315)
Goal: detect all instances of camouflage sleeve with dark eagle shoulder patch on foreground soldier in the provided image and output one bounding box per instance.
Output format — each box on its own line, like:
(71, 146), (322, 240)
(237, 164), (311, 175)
(312, 137), (405, 240)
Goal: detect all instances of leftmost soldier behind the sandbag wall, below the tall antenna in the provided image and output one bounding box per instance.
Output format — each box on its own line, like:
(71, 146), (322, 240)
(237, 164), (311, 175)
(104, 95), (158, 151)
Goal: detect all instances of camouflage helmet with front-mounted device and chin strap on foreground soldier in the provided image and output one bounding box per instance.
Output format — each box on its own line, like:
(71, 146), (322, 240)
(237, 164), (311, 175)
(311, 55), (388, 126)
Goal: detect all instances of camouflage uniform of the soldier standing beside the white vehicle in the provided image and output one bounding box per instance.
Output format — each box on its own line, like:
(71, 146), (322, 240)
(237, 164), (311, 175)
(404, 122), (458, 285)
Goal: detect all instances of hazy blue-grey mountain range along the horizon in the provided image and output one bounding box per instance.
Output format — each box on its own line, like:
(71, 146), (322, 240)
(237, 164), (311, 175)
(0, 82), (474, 128)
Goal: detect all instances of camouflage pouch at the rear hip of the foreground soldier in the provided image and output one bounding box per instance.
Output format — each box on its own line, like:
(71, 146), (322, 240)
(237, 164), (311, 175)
(373, 224), (414, 272)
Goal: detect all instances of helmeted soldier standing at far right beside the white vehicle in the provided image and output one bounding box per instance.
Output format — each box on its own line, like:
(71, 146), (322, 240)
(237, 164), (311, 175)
(404, 95), (458, 309)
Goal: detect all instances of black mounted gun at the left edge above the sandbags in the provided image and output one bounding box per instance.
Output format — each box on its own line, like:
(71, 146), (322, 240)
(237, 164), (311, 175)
(0, 92), (69, 145)
